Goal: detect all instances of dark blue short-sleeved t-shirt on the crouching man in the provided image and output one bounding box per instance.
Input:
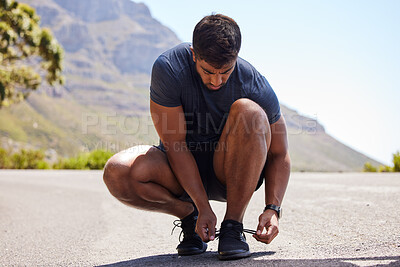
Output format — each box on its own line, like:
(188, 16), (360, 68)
(150, 43), (281, 146)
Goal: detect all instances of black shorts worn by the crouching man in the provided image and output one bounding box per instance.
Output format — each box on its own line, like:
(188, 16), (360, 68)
(154, 142), (266, 202)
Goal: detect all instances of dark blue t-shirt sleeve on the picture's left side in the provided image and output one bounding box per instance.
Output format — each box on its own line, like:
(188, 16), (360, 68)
(150, 55), (181, 107)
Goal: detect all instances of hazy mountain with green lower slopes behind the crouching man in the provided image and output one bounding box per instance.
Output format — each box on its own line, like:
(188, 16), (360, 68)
(0, 0), (379, 171)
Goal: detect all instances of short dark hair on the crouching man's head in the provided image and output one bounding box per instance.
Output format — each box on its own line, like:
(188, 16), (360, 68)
(192, 14), (242, 68)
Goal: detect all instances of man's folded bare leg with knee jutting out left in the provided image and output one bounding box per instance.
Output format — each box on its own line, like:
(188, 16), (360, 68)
(103, 146), (194, 219)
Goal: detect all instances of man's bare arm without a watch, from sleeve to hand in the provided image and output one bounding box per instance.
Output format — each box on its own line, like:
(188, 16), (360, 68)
(150, 101), (217, 242)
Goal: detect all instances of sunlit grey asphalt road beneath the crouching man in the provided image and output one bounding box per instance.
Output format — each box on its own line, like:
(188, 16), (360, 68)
(0, 170), (400, 267)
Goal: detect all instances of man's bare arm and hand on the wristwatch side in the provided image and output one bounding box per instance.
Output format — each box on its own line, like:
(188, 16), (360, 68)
(253, 115), (290, 244)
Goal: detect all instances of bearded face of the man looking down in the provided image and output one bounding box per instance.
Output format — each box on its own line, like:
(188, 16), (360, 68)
(192, 50), (236, 90)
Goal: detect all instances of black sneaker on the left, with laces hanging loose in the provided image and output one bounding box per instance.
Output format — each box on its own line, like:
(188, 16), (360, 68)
(172, 208), (207, 256)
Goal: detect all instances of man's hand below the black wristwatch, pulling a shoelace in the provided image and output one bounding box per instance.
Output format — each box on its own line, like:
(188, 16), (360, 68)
(253, 210), (279, 244)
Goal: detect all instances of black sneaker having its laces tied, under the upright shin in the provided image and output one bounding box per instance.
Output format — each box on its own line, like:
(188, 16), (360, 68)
(218, 220), (251, 260)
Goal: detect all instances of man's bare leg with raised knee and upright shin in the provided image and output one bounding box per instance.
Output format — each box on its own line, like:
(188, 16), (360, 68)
(214, 98), (271, 222)
